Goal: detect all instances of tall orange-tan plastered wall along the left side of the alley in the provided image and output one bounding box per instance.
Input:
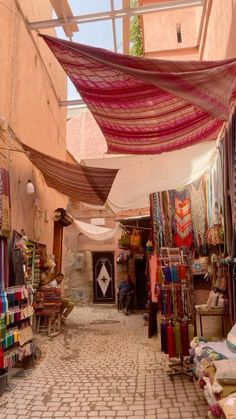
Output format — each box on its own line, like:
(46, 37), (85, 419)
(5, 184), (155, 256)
(0, 0), (67, 252)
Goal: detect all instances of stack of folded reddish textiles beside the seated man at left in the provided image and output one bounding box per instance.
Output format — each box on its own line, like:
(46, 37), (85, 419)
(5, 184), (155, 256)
(34, 287), (62, 314)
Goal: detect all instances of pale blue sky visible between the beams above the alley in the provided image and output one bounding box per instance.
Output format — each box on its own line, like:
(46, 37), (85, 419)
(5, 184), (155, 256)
(55, 0), (122, 100)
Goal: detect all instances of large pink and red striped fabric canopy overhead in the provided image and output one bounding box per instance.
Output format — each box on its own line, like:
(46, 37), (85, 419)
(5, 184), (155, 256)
(42, 35), (236, 154)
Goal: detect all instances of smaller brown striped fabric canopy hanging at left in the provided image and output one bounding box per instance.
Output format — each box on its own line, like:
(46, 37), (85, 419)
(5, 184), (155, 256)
(21, 143), (118, 205)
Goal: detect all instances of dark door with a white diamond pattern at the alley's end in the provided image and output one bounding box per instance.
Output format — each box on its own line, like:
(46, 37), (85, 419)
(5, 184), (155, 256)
(92, 252), (115, 303)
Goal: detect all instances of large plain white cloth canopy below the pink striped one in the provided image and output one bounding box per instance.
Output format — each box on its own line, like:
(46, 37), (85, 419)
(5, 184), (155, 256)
(81, 141), (216, 213)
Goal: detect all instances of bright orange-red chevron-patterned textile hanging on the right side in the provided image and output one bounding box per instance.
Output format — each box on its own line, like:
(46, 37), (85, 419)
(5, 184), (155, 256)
(172, 189), (193, 247)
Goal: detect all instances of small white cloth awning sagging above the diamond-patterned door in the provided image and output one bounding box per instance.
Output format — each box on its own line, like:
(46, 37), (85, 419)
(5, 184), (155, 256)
(74, 219), (122, 241)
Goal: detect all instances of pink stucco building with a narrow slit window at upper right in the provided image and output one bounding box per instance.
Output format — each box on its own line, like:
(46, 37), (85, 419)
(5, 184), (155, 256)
(139, 0), (236, 60)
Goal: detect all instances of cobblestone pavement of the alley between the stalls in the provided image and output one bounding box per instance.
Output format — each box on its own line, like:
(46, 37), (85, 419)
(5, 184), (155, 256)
(0, 306), (207, 419)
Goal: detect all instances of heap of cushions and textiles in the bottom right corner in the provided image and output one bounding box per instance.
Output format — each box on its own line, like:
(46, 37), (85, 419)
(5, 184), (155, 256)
(190, 324), (236, 419)
